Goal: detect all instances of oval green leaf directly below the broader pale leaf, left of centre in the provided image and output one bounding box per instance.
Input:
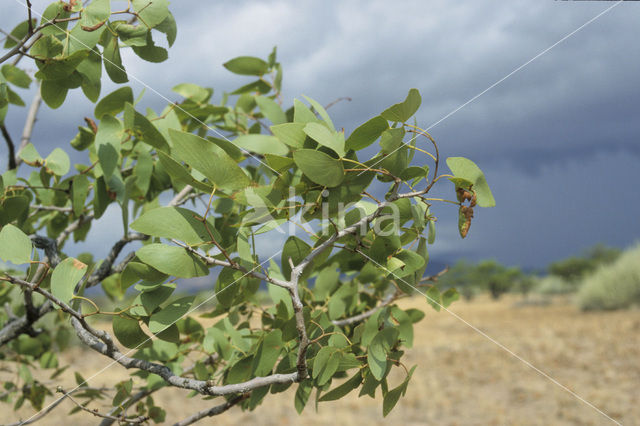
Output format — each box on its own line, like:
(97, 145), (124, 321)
(136, 244), (209, 278)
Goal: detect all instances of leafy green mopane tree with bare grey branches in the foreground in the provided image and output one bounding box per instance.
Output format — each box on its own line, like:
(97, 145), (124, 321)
(0, 0), (494, 425)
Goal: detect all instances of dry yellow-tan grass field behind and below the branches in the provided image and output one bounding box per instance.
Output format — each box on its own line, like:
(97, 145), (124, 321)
(2, 297), (640, 425)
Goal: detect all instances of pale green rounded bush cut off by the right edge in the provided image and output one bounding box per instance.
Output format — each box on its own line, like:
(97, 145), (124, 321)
(578, 244), (640, 310)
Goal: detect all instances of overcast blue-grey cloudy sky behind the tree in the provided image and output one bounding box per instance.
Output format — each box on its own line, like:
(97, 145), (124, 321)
(0, 0), (640, 268)
